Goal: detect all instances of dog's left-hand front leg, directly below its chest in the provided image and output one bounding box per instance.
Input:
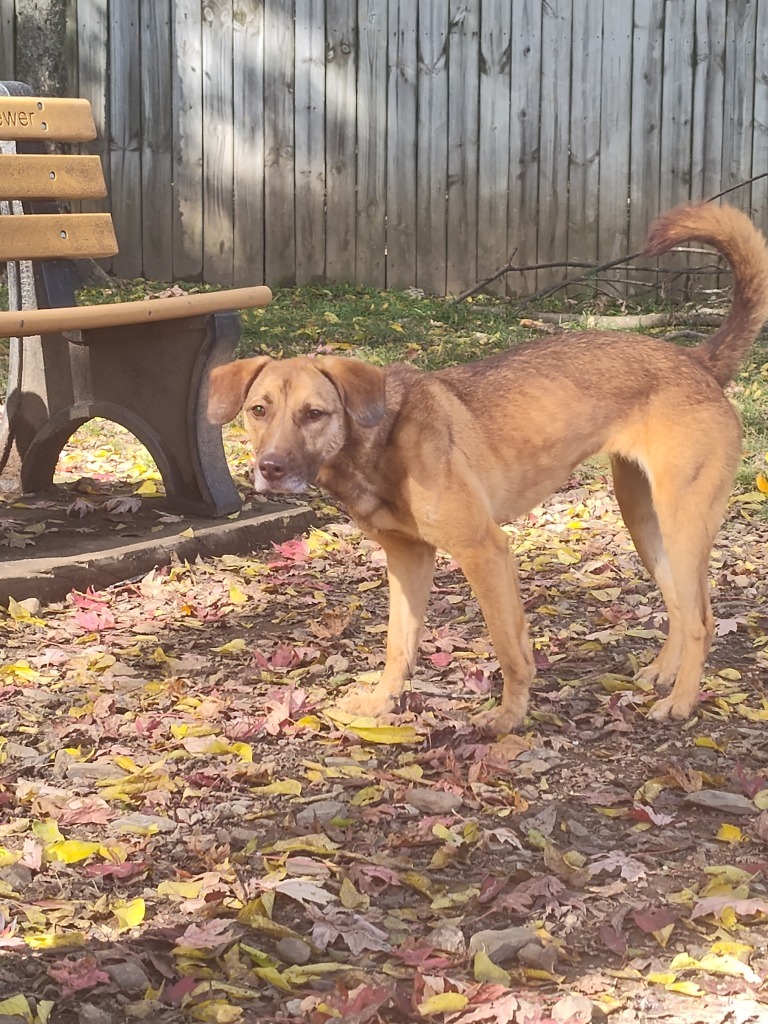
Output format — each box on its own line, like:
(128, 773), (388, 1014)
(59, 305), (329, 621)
(341, 534), (435, 716)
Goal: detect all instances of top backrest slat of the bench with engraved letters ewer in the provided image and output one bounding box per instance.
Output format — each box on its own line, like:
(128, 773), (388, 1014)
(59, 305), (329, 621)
(0, 96), (96, 142)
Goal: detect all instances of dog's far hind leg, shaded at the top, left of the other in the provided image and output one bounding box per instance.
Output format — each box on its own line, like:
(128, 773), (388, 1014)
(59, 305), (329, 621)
(610, 456), (683, 687)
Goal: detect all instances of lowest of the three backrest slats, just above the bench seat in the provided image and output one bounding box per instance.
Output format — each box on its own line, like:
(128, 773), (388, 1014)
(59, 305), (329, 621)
(0, 213), (118, 260)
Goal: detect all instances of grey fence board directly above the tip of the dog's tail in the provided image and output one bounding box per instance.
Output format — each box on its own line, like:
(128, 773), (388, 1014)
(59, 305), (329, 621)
(627, 0), (665, 285)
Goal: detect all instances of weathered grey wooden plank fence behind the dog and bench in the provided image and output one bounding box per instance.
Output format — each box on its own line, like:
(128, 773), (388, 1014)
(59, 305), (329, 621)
(0, 0), (768, 293)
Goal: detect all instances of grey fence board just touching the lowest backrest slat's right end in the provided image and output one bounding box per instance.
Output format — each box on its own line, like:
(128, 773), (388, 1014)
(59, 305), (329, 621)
(105, 0), (141, 278)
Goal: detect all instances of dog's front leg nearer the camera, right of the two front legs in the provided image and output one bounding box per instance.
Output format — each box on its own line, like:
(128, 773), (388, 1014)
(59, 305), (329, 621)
(452, 524), (536, 735)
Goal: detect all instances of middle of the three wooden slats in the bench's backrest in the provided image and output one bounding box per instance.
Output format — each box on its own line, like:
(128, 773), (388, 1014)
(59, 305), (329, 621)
(0, 154), (106, 200)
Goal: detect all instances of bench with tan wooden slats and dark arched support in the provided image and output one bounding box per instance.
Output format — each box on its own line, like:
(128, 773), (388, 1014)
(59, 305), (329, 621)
(0, 82), (271, 516)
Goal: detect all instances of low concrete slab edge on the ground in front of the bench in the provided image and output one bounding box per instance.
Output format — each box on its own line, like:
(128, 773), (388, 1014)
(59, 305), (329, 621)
(0, 502), (315, 604)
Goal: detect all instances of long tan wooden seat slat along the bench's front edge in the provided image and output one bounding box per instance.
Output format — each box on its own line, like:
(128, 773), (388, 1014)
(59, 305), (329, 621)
(0, 284), (272, 339)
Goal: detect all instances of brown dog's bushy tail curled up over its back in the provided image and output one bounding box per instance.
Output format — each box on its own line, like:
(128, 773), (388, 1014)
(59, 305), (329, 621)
(645, 203), (768, 386)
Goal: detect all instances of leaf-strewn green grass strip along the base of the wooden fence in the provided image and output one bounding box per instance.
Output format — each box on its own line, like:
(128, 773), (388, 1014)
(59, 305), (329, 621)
(6, 281), (768, 492)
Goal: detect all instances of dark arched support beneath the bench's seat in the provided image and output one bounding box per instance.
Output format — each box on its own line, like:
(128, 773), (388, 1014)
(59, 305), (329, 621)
(9, 312), (241, 517)
